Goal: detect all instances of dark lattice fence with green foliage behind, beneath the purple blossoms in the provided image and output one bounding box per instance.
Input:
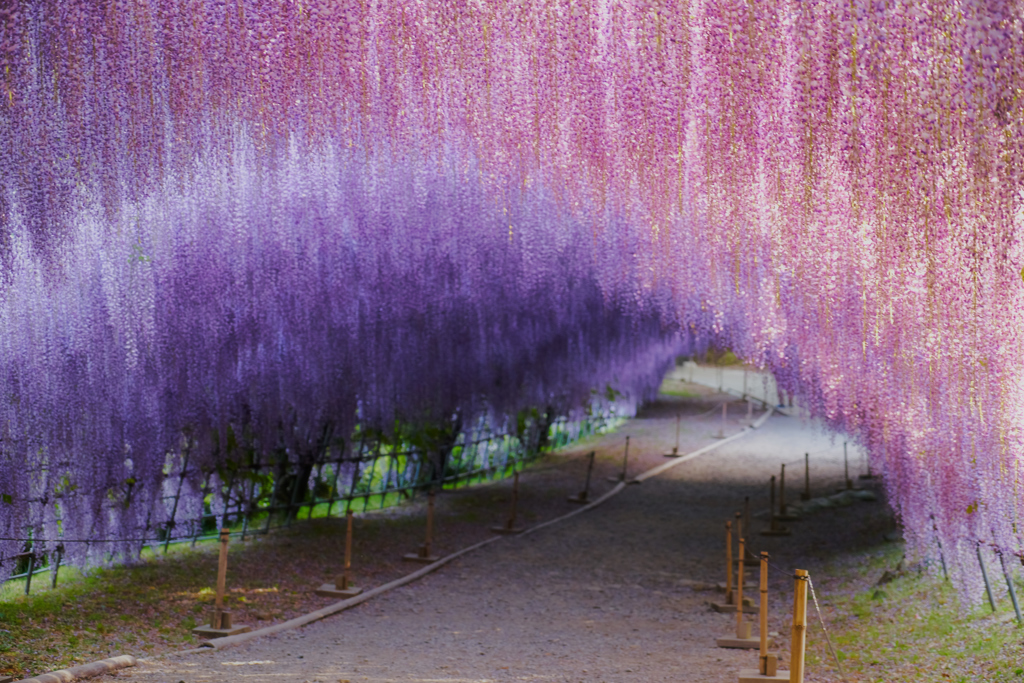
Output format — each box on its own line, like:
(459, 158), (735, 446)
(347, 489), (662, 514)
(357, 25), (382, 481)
(0, 404), (624, 594)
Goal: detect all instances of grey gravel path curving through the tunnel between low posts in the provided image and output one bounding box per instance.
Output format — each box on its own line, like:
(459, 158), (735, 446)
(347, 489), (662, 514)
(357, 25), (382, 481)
(110, 373), (884, 683)
